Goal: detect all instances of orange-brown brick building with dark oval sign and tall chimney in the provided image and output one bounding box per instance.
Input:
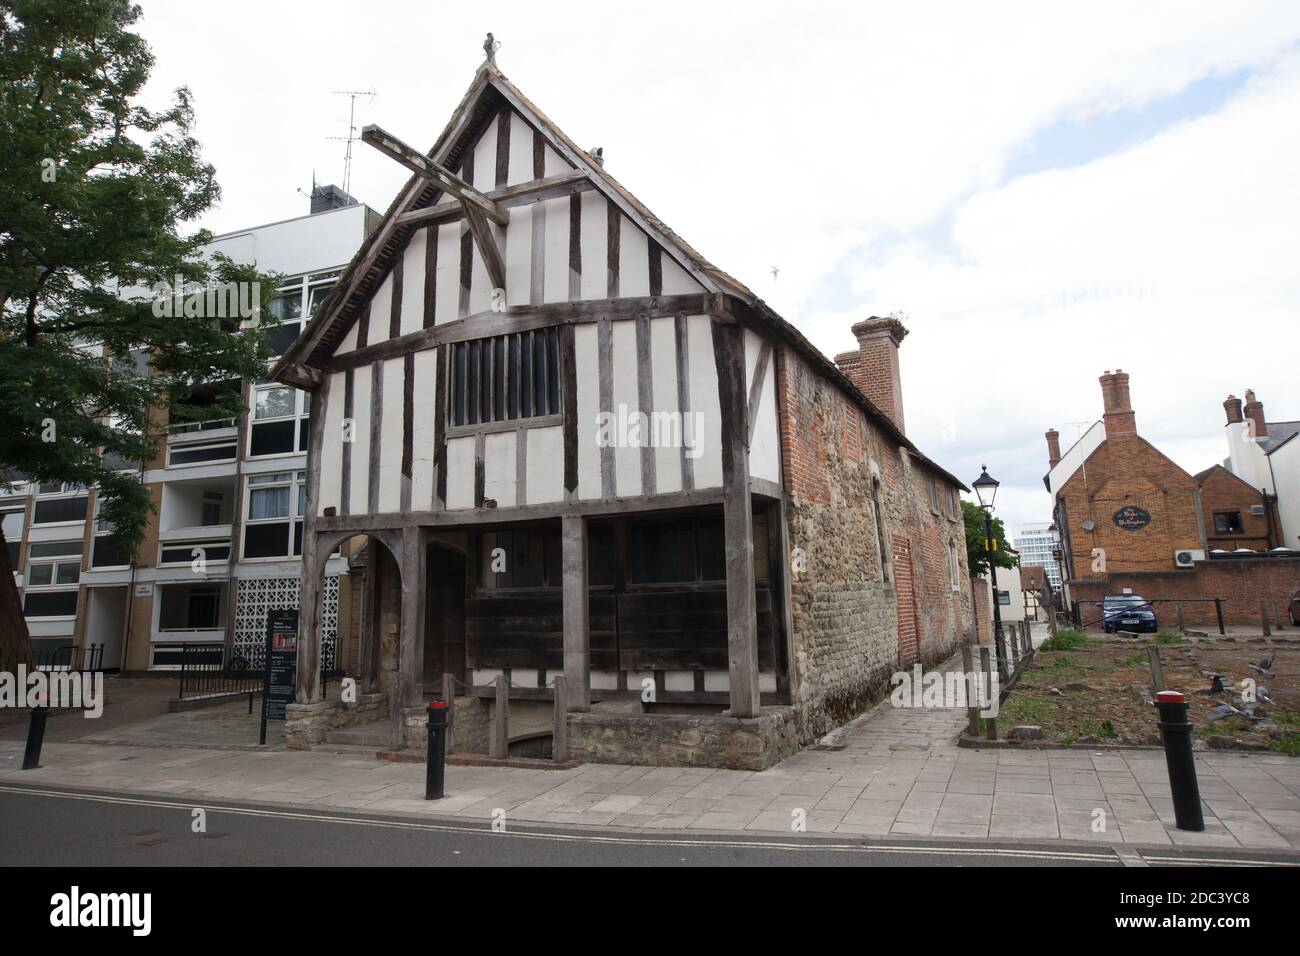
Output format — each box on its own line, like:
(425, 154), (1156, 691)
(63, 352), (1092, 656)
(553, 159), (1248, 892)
(1044, 369), (1300, 623)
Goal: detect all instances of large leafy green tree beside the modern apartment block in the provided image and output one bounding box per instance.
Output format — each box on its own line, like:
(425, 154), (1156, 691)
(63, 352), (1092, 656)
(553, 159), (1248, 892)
(0, 0), (274, 670)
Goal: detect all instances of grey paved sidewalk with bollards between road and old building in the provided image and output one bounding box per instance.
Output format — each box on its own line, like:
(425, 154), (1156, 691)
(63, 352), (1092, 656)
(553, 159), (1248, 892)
(0, 629), (1300, 862)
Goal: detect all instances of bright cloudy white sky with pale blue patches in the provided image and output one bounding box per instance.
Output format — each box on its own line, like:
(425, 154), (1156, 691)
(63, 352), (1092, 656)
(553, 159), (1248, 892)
(131, 0), (1300, 528)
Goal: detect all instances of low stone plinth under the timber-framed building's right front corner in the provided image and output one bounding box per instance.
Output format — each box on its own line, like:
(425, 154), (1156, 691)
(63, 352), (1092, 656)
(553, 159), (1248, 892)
(568, 708), (800, 770)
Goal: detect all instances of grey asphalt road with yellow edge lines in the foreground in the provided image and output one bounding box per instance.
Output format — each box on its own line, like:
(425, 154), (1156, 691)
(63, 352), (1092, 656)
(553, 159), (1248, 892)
(0, 784), (1297, 868)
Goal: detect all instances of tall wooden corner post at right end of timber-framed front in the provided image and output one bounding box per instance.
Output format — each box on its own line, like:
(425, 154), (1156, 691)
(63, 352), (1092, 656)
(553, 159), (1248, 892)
(711, 313), (761, 717)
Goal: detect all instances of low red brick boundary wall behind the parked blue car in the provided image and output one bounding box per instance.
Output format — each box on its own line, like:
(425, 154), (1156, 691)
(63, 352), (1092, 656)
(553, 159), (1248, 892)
(1070, 558), (1300, 627)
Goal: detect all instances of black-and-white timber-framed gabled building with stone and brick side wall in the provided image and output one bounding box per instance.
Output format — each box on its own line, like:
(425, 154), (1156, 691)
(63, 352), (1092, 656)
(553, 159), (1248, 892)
(272, 62), (974, 767)
